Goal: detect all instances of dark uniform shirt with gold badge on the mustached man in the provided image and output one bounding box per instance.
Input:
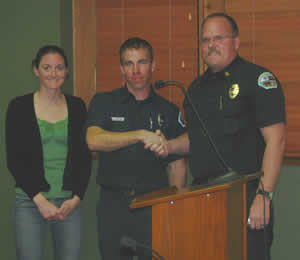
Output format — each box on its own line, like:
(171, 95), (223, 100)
(184, 57), (285, 179)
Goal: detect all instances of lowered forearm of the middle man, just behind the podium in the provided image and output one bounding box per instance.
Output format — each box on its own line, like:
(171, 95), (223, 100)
(169, 159), (186, 188)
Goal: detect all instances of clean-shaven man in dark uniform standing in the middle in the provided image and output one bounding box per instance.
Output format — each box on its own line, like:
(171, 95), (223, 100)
(87, 38), (185, 260)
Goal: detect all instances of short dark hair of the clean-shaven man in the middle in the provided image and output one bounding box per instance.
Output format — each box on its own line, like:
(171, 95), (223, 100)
(120, 37), (153, 65)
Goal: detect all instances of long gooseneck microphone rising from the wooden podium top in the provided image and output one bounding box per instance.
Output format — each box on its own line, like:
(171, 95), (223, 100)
(154, 80), (243, 184)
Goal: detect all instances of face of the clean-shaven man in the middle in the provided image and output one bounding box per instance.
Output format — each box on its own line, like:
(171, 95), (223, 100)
(121, 48), (155, 92)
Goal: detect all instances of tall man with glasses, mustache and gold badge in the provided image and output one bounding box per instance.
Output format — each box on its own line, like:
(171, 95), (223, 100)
(150, 13), (286, 260)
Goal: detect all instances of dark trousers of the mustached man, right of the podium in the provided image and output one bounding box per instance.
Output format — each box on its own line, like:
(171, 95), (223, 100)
(247, 180), (274, 260)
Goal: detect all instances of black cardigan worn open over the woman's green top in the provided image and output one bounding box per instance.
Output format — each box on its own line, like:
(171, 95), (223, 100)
(6, 93), (91, 199)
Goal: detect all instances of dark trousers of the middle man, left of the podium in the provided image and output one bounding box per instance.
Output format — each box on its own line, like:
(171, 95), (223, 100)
(97, 189), (152, 260)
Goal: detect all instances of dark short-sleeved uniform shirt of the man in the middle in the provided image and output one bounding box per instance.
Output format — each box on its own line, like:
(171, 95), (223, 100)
(87, 87), (184, 191)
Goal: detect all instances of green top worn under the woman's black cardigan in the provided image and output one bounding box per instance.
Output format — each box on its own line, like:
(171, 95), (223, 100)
(16, 118), (72, 198)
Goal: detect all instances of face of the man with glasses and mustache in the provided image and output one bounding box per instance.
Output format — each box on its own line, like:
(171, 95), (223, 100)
(201, 17), (240, 72)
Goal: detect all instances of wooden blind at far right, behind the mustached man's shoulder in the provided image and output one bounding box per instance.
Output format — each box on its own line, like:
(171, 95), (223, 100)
(226, 0), (300, 158)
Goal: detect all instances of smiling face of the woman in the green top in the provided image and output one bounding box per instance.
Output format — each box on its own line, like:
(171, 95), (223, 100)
(33, 53), (68, 89)
